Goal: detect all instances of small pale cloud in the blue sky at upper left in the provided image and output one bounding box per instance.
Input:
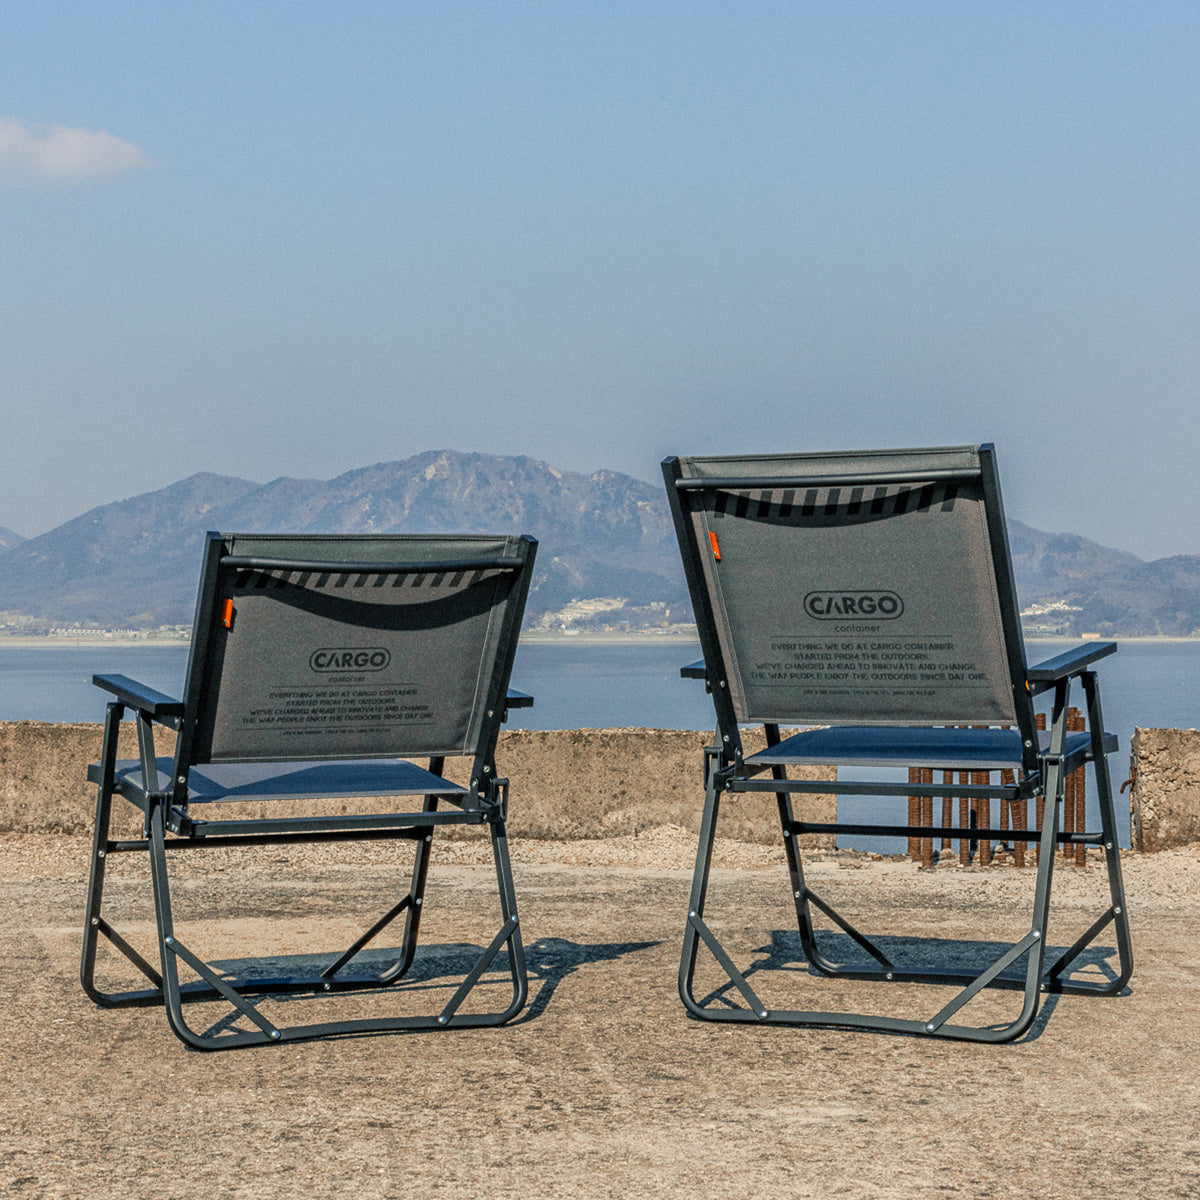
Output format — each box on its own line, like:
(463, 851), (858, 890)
(0, 116), (148, 187)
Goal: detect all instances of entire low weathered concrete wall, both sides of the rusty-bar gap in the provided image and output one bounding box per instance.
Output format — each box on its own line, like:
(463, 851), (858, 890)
(16, 721), (1200, 851)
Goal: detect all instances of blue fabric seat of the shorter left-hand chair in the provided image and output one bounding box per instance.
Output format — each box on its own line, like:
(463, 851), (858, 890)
(88, 758), (467, 804)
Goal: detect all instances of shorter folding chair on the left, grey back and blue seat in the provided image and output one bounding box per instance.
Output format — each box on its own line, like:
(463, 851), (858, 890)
(82, 533), (536, 1049)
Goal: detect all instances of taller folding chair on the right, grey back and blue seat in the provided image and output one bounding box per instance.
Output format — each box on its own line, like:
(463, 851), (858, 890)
(662, 445), (1133, 1042)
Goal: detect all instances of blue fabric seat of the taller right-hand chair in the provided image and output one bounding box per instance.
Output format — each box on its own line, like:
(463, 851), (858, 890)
(745, 725), (1116, 770)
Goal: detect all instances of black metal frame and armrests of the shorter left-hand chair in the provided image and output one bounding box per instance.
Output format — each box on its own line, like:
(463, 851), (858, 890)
(80, 534), (535, 1050)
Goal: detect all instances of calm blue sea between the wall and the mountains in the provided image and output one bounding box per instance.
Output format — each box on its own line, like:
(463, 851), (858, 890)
(0, 638), (1200, 852)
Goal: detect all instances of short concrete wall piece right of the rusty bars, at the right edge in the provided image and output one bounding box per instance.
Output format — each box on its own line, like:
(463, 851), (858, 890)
(1130, 730), (1200, 850)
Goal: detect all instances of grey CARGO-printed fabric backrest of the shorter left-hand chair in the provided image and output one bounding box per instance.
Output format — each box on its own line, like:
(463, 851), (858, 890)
(176, 533), (536, 780)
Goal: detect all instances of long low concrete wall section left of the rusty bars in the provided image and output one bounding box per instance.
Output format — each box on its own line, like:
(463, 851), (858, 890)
(0, 721), (836, 847)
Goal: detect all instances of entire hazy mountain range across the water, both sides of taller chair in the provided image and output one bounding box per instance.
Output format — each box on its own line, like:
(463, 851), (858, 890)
(0, 450), (1200, 637)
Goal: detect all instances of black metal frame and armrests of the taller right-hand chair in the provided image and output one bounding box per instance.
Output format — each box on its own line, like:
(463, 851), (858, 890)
(664, 446), (1133, 1042)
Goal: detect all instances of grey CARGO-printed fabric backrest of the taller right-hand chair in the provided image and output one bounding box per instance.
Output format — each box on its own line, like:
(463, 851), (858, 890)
(662, 445), (1033, 736)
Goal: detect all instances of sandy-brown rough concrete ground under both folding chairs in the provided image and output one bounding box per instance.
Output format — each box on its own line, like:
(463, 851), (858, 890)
(0, 830), (1200, 1200)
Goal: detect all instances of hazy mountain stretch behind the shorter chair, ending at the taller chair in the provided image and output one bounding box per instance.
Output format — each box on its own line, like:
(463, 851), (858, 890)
(0, 450), (690, 628)
